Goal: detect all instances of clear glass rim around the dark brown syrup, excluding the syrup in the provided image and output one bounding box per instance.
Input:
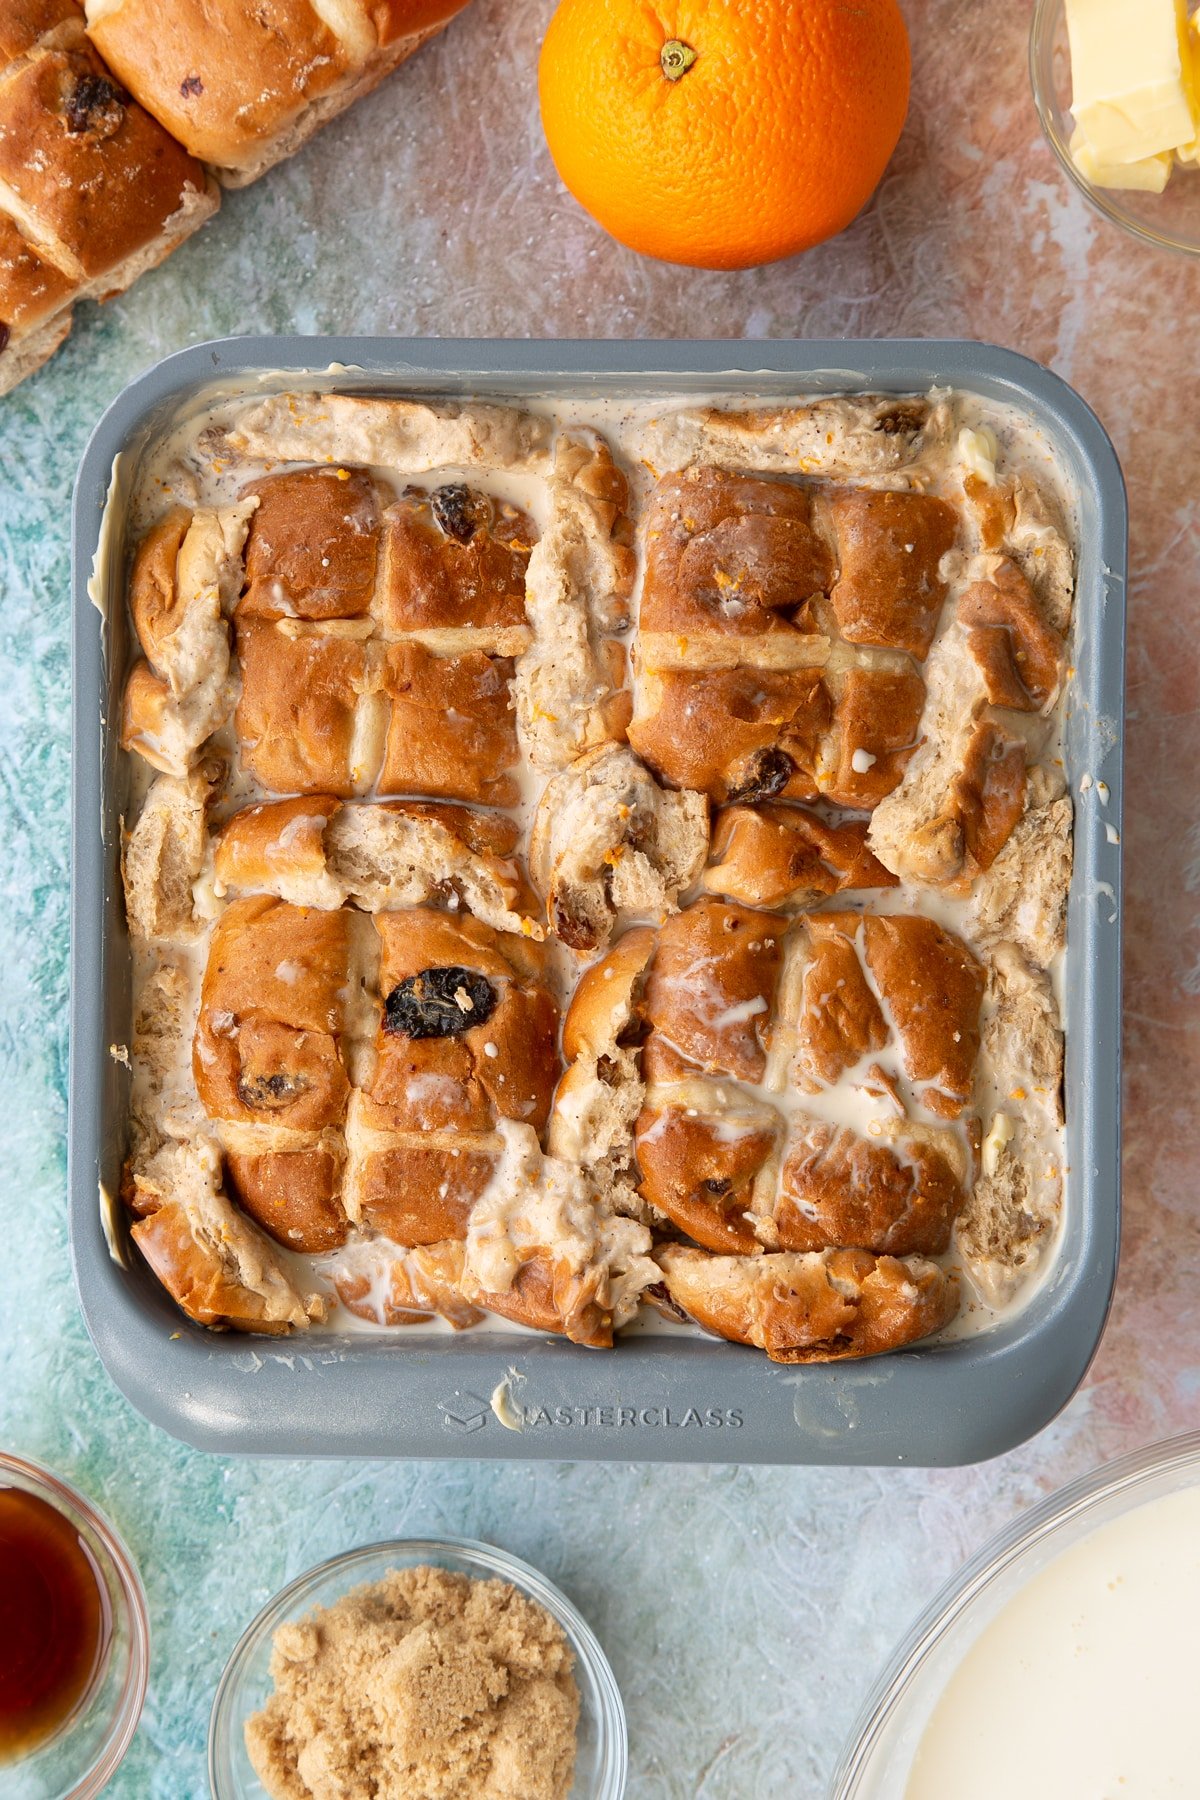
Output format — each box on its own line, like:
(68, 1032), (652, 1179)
(0, 1451), (149, 1800)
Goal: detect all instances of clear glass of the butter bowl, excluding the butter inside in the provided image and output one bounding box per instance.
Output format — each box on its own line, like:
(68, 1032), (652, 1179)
(1029, 0), (1200, 256)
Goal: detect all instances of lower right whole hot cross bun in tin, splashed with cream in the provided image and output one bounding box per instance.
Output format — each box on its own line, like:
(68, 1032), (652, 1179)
(633, 900), (984, 1255)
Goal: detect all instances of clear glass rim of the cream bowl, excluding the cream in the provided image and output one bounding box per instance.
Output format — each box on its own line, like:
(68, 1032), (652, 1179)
(829, 1431), (1200, 1800)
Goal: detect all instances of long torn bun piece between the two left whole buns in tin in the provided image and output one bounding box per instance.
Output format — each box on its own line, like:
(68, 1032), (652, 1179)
(214, 794), (545, 941)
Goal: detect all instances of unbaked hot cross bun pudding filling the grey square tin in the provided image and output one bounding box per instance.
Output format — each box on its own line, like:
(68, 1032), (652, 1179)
(112, 392), (1074, 1363)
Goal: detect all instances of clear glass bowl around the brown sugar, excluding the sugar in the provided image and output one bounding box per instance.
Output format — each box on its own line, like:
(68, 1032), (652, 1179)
(209, 1537), (628, 1800)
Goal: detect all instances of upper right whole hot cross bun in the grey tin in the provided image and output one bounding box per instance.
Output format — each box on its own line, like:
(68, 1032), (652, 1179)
(630, 464), (957, 810)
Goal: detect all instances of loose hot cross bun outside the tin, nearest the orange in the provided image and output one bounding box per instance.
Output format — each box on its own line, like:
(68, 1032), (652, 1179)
(86, 0), (466, 187)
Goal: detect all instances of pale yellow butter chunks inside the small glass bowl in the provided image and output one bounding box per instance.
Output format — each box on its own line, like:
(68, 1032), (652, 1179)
(1067, 0), (1196, 166)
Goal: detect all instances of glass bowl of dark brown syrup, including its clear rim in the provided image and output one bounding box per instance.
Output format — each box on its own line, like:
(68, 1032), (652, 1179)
(0, 1451), (149, 1800)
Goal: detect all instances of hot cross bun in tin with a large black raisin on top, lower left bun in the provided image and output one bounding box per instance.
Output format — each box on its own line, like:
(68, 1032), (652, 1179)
(193, 895), (558, 1253)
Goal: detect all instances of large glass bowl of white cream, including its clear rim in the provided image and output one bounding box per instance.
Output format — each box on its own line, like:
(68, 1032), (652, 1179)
(829, 1433), (1200, 1800)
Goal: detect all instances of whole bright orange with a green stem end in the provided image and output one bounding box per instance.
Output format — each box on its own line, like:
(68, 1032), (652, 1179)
(540, 0), (910, 268)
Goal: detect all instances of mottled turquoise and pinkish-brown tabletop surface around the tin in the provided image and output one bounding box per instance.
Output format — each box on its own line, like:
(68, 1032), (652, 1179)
(0, 0), (1200, 1800)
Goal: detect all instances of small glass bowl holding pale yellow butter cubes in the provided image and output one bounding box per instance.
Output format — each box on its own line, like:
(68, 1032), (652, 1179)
(1029, 0), (1200, 256)
